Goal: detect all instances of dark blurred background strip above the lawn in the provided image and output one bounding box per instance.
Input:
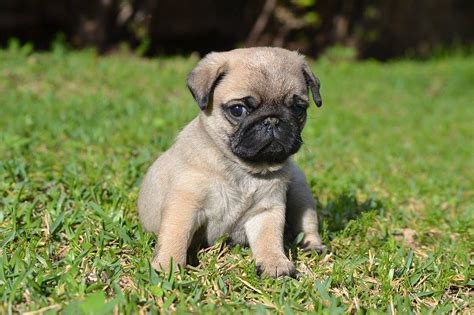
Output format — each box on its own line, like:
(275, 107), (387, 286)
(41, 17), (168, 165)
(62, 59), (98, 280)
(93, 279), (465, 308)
(0, 0), (474, 60)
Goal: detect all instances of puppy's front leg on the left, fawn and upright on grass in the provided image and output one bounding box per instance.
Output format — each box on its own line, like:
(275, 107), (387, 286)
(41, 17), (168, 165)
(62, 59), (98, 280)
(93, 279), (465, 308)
(152, 193), (198, 271)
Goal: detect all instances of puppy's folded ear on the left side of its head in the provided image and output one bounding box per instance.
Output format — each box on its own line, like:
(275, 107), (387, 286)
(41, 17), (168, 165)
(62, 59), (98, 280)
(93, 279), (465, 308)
(186, 53), (227, 110)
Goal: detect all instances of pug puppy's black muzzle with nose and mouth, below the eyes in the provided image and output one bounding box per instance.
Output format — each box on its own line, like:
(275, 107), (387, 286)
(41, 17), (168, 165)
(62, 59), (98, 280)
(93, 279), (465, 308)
(230, 119), (303, 164)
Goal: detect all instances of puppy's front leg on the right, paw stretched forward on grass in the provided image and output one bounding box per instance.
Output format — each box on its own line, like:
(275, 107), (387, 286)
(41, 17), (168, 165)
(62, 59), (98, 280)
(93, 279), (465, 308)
(245, 205), (296, 277)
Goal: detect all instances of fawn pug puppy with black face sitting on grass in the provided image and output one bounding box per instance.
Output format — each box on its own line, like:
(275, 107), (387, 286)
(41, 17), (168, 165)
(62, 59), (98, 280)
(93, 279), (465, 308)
(138, 47), (324, 277)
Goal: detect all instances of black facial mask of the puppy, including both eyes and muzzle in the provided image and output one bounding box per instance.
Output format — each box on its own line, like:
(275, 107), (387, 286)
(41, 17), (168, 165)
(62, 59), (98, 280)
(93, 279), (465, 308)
(219, 93), (308, 164)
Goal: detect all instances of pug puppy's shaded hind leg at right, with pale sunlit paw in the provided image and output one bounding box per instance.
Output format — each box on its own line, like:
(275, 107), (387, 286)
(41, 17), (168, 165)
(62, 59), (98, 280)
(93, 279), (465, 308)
(286, 165), (325, 253)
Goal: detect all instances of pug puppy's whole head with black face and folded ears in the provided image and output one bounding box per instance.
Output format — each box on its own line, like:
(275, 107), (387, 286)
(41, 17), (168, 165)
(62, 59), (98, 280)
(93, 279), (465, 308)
(187, 47), (322, 165)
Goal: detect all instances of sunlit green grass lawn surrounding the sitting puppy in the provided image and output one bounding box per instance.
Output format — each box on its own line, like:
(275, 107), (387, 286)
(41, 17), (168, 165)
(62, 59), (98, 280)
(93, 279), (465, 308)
(0, 48), (474, 314)
